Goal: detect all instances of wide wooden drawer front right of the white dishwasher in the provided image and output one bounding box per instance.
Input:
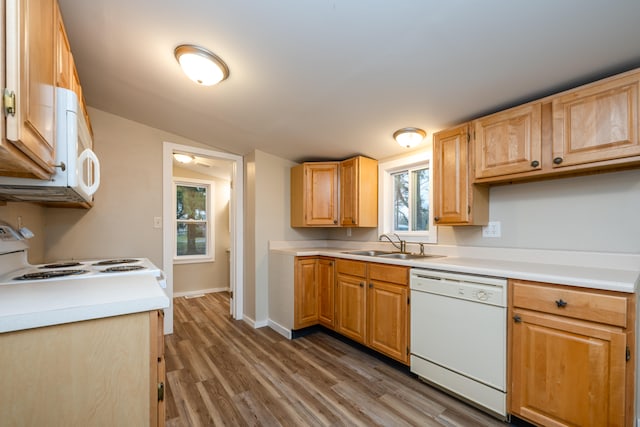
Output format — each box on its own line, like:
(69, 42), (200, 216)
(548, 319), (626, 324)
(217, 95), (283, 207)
(512, 281), (627, 328)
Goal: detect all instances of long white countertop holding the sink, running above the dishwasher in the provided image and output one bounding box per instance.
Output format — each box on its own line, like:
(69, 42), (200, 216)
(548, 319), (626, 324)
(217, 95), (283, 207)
(272, 247), (640, 293)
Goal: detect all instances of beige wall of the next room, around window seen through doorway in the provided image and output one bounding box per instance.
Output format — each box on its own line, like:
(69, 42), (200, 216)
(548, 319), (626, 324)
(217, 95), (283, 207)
(173, 167), (231, 294)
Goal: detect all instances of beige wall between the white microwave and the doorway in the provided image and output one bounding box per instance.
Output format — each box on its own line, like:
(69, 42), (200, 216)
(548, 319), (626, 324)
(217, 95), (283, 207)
(44, 108), (224, 266)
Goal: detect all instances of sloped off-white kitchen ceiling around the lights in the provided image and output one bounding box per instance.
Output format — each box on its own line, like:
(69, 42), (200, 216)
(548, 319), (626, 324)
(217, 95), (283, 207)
(59, 0), (640, 161)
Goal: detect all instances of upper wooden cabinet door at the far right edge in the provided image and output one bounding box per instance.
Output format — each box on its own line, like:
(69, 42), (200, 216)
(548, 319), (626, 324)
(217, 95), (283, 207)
(552, 73), (640, 167)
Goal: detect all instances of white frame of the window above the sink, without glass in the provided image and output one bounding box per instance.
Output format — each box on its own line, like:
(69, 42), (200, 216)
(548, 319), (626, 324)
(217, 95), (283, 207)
(378, 147), (438, 243)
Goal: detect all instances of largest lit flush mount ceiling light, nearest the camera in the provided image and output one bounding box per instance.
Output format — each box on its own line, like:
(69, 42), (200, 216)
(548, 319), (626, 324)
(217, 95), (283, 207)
(174, 44), (229, 86)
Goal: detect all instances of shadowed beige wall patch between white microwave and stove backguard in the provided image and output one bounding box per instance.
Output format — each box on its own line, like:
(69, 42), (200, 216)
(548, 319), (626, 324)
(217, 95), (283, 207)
(0, 202), (47, 264)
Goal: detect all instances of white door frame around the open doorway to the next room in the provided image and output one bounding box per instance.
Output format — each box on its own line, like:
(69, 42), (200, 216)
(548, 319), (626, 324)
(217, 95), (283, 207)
(162, 141), (244, 334)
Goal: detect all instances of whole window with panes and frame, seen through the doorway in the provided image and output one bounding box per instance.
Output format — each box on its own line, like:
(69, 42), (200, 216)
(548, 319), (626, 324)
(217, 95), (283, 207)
(173, 178), (214, 263)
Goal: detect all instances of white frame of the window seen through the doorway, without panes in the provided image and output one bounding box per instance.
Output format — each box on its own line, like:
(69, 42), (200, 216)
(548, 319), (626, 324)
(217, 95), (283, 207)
(172, 177), (215, 264)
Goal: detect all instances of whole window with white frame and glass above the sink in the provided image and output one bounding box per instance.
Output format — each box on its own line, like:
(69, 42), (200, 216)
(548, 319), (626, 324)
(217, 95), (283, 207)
(379, 150), (437, 243)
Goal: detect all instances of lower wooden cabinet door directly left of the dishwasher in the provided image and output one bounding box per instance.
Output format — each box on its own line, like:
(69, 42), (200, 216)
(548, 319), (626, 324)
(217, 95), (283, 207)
(367, 280), (409, 364)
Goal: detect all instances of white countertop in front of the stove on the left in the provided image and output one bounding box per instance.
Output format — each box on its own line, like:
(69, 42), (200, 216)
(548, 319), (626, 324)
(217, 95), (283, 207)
(0, 274), (170, 333)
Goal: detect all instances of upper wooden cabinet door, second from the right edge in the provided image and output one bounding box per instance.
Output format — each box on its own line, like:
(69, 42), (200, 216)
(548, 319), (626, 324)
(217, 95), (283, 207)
(473, 103), (542, 178)
